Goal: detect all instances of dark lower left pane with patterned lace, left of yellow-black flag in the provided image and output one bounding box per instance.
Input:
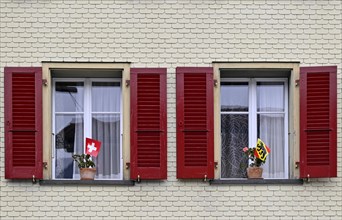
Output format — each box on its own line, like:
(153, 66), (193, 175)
(221, 114), (248, 178)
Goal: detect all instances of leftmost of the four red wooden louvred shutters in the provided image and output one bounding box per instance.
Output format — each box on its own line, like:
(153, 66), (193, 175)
(5, 67), (43, 179)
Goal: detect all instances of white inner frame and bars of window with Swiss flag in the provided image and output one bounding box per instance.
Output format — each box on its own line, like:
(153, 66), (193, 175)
(51, 78), (123, 180)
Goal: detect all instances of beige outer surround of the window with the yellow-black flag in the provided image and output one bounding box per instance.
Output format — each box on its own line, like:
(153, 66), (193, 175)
(213, 61), (300, 181)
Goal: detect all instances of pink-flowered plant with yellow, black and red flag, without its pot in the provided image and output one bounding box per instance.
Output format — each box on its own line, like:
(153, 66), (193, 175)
(242, 139), (271, 167)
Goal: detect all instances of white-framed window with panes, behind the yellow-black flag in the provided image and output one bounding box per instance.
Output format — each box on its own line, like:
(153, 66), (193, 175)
(220, 78), (288, 179)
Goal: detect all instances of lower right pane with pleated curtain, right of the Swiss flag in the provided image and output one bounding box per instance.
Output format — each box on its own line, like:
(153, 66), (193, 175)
(92, 114), (120, 179)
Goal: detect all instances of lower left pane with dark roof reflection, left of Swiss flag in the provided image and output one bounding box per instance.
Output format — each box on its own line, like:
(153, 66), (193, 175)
(55, 115), (83, 179)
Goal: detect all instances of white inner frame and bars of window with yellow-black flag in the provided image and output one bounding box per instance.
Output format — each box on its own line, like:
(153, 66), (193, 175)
(219, 77), (290, 180)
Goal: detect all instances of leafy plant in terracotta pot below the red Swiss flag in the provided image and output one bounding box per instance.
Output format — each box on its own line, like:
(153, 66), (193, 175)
(72, 154), (96, 180)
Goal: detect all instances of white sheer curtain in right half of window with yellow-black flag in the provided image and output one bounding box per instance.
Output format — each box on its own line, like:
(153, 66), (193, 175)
(257, 81), (288, 178)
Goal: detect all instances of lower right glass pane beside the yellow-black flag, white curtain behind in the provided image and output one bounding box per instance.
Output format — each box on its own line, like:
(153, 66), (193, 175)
(257, 114), (287, 178)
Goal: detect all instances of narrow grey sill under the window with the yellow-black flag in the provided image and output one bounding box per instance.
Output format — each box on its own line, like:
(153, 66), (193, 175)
(210, 179), (304, 185)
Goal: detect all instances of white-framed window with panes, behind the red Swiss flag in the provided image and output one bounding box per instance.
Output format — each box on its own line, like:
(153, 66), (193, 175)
(52, 78), (122, 179)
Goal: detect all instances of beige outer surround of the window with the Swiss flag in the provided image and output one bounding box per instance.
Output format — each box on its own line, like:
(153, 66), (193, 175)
(42, 61), (130, 181)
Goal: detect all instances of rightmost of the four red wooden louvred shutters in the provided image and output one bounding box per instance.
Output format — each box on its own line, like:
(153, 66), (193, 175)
(300, 66), (337, 178)
